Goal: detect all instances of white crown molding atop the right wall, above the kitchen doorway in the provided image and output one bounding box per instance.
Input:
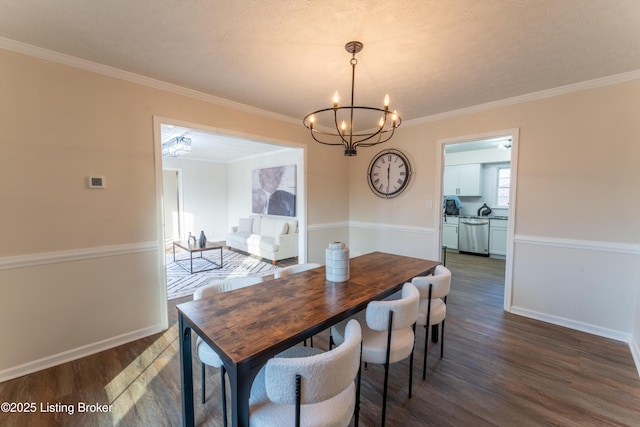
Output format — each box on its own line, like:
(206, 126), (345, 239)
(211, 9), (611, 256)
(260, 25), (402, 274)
(402, 70), (640, 127)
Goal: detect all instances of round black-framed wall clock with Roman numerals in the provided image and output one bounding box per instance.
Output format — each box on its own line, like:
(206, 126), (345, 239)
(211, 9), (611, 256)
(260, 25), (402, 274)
(368, 149), (411, 199)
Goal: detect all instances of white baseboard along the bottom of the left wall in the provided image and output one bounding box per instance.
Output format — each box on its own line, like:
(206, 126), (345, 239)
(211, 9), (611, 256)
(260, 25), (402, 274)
(0, 324), (164, 383)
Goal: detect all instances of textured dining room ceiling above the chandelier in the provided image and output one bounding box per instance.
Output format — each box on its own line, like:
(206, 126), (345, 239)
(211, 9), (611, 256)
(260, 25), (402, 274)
(0, 0), (640, 160)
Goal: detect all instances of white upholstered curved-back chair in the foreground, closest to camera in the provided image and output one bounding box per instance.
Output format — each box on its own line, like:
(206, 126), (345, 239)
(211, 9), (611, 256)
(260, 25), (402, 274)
(249, 320), (362, 427)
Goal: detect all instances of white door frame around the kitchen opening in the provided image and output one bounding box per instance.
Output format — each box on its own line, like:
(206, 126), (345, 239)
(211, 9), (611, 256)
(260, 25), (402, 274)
(434, 128), (520, 312)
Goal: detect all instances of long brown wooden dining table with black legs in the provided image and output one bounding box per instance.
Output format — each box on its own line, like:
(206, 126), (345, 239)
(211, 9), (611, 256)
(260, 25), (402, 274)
(177, 252), (440, 427)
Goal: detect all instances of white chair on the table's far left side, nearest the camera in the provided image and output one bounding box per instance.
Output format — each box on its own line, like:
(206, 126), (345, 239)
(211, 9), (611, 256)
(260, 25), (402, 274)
(193, 276), (262, 427)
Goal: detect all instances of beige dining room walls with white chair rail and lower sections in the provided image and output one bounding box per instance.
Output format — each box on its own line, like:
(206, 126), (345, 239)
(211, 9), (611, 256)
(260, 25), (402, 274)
(0, 50), (640, 381)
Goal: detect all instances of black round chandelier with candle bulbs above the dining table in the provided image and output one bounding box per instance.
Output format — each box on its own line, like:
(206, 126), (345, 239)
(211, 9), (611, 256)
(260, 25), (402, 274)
(302, 41), (402, 156)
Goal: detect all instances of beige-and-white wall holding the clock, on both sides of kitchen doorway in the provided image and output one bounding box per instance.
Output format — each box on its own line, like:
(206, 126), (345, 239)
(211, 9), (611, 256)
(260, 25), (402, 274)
(350, 80), (640, 343)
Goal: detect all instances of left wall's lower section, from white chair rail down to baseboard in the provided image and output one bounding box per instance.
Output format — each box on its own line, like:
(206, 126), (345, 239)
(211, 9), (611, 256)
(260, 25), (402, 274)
(0, 242), (167, 382)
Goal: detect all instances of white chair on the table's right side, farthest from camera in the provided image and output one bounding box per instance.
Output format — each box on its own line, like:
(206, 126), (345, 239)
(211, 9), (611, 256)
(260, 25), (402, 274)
(411, 265), (451, 380)
